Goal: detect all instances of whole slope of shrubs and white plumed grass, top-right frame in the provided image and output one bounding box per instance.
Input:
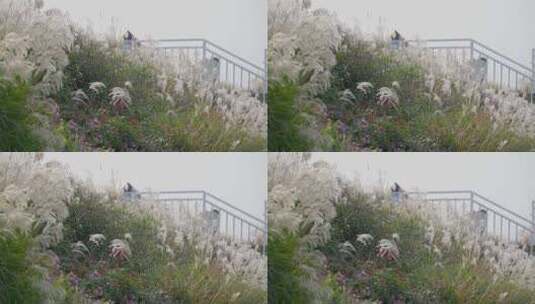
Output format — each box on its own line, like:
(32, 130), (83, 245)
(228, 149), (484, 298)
(269, 0), (535, 152)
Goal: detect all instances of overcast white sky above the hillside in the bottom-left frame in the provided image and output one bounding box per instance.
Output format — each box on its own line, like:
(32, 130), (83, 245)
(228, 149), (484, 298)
(45, 153), (267, 219)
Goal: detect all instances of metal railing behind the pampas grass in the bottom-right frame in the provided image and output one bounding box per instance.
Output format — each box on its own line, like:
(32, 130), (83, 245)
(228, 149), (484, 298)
(407, 191), (535, 254)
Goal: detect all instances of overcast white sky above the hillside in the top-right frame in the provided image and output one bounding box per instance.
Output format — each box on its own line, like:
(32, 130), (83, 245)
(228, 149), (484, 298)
(313, 0), (535, 66)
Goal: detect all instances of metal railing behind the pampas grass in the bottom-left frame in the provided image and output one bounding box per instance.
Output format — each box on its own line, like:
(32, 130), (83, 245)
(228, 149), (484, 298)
(140, 191), (267, 252)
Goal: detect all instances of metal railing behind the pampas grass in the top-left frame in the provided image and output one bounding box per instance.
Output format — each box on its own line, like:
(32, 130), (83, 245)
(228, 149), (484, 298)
(140, 39), (267, 100)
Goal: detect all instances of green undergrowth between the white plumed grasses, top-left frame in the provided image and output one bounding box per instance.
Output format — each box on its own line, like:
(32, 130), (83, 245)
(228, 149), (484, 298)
(58, 33), (265, 151)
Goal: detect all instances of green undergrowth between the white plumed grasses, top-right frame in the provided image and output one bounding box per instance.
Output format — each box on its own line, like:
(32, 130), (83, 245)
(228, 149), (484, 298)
(320, 37), (535, 151)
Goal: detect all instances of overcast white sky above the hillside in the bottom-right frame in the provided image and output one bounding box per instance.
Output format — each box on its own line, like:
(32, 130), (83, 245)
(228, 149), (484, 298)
(313, 153), (535, 217)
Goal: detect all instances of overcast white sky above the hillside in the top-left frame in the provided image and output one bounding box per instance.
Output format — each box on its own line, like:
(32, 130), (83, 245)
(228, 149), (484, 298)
(45, 0), (267, 66)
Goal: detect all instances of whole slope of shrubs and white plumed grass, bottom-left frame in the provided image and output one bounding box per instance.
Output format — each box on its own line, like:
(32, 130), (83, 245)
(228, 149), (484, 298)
(0, 154), (267, 304)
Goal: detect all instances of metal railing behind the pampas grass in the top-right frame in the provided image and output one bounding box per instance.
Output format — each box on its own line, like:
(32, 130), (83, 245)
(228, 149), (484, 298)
(407, 38), (535, 102)
